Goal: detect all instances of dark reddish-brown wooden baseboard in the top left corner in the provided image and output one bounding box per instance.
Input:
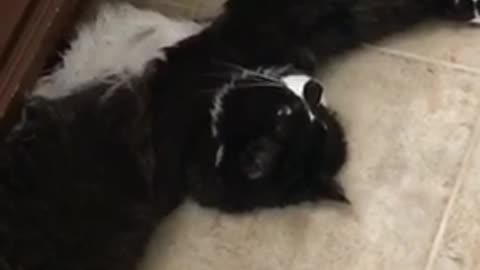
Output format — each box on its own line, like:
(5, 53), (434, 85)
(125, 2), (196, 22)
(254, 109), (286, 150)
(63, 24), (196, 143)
(0, 0), (82, 121)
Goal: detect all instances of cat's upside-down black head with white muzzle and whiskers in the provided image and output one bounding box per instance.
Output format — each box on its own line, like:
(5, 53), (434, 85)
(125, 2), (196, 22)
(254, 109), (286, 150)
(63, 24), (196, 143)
(190, 66), (347, 211)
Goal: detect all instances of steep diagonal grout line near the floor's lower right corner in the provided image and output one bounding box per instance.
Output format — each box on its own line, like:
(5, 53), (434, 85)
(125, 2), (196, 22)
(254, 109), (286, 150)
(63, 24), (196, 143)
(424, 108), (480, 270)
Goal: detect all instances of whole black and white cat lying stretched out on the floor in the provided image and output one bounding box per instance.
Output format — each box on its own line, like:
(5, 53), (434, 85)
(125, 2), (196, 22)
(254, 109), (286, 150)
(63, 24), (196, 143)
(0, 0), (478, 270)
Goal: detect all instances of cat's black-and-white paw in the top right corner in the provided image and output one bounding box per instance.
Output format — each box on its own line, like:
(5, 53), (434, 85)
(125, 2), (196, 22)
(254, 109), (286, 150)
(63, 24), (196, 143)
(444, 0), (480, 25)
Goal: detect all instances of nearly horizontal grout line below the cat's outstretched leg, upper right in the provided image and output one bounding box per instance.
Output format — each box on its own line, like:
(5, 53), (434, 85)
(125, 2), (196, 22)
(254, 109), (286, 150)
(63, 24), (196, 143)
(363, 44), (480, 75)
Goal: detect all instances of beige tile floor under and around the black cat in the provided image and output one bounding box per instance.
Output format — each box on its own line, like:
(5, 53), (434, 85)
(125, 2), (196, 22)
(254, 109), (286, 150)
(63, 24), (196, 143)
(115, 0), (480, 270)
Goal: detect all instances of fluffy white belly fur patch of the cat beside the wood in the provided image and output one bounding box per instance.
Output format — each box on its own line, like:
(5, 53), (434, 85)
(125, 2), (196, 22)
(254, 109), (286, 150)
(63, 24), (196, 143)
(33, 4), (203, 98)
